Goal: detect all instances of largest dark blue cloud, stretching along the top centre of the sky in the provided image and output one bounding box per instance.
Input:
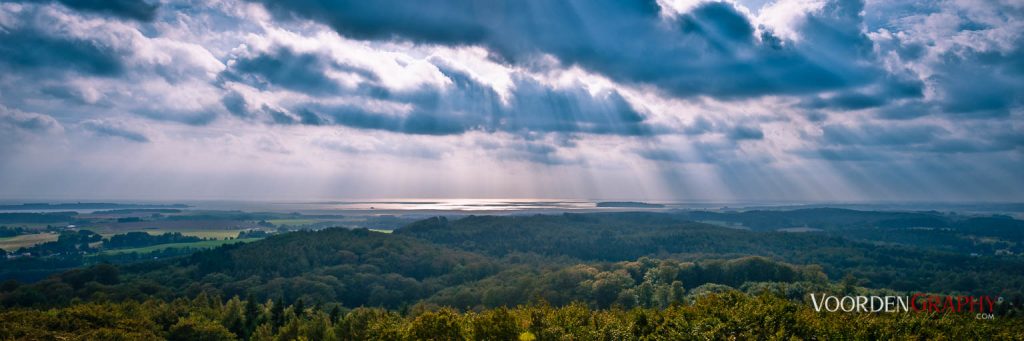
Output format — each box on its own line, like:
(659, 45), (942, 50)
(245, 0), (881, 97)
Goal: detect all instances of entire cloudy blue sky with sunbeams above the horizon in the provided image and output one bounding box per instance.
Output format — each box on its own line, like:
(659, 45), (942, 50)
(0, 0), (1024, 202)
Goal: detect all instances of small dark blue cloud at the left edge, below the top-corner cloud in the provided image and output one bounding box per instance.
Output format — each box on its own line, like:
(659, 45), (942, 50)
(0, 29), (125, 77)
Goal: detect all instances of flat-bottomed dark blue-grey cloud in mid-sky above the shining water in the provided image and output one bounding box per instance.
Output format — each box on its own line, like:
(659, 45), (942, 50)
(317, 71), (650, 135)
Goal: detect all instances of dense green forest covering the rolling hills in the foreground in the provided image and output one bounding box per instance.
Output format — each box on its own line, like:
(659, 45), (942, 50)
(0, 211), (1024, 340)
